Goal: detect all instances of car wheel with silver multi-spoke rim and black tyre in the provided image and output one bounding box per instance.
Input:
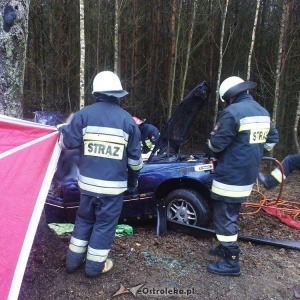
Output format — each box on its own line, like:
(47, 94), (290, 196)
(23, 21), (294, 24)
(166, 189), (210, 226)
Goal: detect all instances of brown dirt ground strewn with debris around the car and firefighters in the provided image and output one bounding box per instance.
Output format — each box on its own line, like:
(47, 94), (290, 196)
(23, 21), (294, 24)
(19, 172), (300, 300)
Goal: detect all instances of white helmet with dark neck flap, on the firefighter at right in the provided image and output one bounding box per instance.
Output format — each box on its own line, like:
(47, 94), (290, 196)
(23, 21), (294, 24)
(219, 76), (257, 104)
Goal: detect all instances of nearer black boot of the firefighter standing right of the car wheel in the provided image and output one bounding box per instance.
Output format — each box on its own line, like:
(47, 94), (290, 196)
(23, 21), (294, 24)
(207, 247), (241, 276)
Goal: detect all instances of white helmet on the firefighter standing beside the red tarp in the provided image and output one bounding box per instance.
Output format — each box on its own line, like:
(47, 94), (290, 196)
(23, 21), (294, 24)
(93, 71), (128, 98)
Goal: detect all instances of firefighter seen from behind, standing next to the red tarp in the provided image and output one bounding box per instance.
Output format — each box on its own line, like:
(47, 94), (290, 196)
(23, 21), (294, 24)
(59, 71), (143, 277)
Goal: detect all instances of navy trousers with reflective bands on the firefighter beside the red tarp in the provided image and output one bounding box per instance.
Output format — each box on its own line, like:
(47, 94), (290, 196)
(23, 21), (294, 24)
(67, 193), (123, 276)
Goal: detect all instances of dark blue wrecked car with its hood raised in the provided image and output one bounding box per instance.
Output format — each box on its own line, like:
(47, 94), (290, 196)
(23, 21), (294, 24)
(45, 82), (215, 226)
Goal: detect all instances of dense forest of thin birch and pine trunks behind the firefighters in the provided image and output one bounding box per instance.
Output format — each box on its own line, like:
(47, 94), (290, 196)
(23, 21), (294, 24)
(0, 0), (300, 158)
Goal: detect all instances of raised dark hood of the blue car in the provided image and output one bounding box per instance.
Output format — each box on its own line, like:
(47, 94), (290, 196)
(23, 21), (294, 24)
(148, 81), (210, 162)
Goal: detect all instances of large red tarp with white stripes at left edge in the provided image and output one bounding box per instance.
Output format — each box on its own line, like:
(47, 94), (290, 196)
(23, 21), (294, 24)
(0, 115), (60, 299)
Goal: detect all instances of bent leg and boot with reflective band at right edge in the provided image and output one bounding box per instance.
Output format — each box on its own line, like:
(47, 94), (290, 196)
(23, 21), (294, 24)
(258, 153), (300, 190)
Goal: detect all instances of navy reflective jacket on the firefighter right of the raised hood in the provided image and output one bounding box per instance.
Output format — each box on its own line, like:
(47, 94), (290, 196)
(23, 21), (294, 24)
(208, 93), (278, 203)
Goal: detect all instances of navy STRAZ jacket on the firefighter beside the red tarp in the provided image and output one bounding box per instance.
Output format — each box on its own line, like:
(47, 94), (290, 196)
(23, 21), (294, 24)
(59, 95), (143, 197)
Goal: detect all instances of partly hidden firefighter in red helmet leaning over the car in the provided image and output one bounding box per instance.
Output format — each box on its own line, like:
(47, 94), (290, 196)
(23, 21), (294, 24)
(133, 117), (159, 154)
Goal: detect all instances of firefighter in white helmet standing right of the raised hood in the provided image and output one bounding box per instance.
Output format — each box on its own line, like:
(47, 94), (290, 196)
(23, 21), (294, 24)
(207, 76), (278, 276)
